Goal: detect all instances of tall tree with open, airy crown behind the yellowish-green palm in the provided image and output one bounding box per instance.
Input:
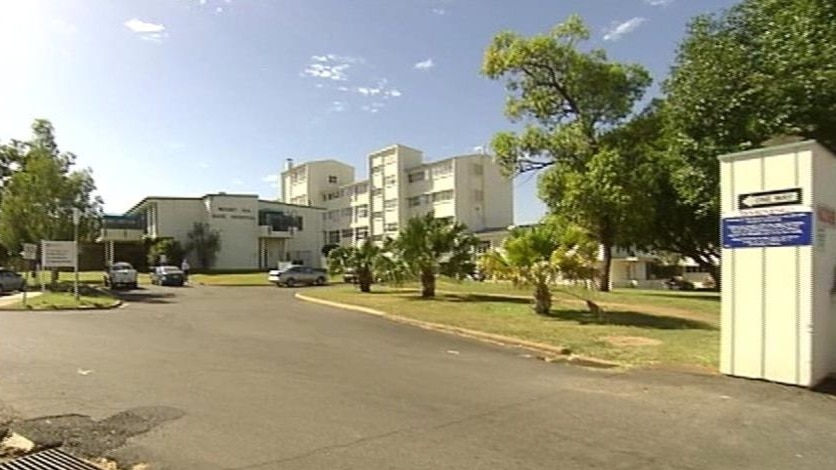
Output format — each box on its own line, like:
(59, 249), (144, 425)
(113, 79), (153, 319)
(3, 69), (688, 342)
(482, 16), (651, 290)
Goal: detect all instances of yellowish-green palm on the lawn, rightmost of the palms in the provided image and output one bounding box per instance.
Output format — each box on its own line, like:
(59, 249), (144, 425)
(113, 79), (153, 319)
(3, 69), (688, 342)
(479, 225), (560, 315)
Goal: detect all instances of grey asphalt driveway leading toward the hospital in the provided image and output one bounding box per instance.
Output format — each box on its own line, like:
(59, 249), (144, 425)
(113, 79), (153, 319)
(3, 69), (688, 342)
(0, 287), (836, 470)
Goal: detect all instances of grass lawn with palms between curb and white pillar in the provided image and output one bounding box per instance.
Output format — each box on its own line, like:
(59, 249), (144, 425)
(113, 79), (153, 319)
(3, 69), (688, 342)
(304, 283), (720, 369)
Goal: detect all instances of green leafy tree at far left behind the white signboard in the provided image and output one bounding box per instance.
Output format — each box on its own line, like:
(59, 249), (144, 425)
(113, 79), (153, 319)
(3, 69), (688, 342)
(0, 120), (102, 253)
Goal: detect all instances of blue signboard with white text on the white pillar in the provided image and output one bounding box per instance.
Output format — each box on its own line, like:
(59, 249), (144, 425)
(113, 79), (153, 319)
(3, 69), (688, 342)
(723, 212), (813, 248)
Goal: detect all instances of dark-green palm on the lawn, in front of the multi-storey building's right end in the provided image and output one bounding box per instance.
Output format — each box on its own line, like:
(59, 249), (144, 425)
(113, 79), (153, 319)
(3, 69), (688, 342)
(391, 212), (478, 298)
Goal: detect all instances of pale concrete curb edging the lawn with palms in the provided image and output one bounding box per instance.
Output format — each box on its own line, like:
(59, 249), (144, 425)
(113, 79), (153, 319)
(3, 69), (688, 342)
(294, 292), (626, 369)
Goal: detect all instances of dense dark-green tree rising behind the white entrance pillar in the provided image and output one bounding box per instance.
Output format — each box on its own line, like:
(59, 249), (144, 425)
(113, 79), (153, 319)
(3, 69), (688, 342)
(659, 0), (836, 285)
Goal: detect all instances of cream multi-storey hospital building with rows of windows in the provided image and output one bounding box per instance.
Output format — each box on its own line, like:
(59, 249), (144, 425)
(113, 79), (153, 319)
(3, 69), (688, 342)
(282, 145), (514, 245)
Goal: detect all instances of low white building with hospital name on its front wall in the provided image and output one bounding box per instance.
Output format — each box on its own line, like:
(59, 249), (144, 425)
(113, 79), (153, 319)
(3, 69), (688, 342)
(125, 193), (324, 270)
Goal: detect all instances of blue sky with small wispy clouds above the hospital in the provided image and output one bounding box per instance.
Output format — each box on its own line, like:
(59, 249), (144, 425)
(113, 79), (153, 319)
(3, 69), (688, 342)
(0, 0), (734, 223)
